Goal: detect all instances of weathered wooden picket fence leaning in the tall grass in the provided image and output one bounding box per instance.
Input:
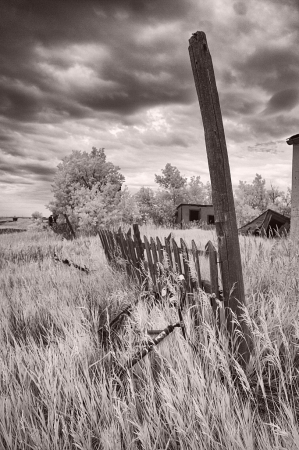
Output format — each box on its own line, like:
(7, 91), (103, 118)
(99, 224), (220, 298)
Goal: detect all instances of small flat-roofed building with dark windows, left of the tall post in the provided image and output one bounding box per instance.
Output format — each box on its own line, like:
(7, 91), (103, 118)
(176, 203), (215, 226)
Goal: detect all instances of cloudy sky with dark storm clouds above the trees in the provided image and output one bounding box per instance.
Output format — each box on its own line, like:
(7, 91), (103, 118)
(0, 0), (299, 216)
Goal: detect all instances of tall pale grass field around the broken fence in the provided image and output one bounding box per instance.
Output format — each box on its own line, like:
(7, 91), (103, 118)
(0, 227), (299, 450)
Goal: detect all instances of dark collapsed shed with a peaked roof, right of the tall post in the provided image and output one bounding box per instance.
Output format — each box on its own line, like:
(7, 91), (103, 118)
(239, 209), (290, 237)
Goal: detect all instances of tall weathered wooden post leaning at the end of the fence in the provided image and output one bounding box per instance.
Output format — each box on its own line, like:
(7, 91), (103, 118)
(189, 31), (252, 364)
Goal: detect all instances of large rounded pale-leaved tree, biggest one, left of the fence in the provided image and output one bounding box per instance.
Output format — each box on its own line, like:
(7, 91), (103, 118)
(48, 147), (124, 232)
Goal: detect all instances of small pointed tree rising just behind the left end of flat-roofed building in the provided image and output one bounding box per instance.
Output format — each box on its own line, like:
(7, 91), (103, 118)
(155, 163), (187, 205)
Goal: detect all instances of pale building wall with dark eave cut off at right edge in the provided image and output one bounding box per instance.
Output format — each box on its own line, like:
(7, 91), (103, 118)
(287, 134), (299, 242)
